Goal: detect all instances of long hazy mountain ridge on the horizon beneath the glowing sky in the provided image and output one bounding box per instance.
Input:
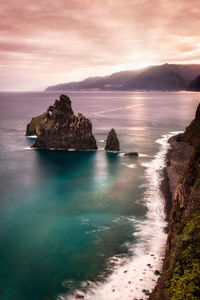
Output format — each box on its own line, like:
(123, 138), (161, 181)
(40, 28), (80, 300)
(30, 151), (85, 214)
(46, 64), (200, 91)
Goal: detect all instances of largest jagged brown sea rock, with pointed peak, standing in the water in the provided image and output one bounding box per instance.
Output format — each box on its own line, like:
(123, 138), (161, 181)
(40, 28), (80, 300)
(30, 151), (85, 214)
(32, 95), (97, 150)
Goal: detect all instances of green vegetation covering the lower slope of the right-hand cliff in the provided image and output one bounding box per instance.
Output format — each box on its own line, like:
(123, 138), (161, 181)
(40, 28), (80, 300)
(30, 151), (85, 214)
(164, 213), (200, 300)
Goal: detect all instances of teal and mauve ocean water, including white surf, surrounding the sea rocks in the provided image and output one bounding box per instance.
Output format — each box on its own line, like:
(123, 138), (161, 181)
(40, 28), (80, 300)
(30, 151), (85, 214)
(0, 92), (200, 300)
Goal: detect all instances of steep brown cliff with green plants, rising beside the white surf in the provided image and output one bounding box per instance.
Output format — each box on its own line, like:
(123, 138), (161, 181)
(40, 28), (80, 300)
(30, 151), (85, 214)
(149, 105), (200, 300)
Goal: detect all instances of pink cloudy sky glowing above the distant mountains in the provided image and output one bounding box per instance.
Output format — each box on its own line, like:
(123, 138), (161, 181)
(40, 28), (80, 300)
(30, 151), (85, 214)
(0, 0), (200, 90)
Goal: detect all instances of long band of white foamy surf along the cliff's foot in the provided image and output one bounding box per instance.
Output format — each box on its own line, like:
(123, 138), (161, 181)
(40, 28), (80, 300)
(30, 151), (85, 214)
(72, 132), (182, 300)
